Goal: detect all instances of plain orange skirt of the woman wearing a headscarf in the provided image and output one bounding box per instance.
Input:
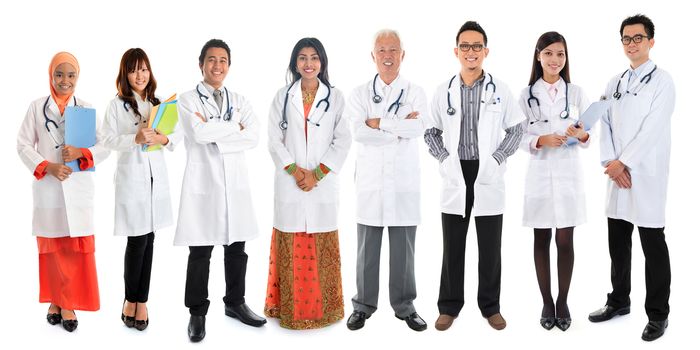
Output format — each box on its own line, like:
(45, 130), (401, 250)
(36, 236), (100, 311)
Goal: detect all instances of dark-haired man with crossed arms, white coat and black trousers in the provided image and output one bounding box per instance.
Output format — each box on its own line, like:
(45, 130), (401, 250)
(175, 39), (266, 342)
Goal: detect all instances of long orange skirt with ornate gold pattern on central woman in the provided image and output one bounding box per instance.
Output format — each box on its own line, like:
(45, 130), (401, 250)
(265, 228), (344, 329)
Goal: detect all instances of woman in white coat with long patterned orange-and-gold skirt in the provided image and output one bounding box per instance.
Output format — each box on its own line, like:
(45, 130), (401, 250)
(265, 38), (352, 329)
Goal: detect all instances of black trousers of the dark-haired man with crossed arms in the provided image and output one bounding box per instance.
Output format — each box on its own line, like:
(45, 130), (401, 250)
(185, 242), (248, 316)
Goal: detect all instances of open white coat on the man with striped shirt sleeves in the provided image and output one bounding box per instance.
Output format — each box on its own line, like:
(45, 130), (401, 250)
(430, 72), (525, 216)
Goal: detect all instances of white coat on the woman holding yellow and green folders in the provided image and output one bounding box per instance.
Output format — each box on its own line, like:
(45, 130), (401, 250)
(102, 96), (182, 236)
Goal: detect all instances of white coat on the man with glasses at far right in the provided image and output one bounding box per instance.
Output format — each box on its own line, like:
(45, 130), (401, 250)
(600, 61), (676, 228)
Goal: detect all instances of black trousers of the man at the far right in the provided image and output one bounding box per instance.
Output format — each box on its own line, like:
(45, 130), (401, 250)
(607, 218), (671, 321)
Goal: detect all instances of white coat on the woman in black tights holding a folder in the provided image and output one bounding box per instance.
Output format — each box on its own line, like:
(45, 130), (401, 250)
(520, 79), (591, 228)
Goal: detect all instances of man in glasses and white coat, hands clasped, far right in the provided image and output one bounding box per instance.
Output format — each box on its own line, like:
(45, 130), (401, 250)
(588, 15), (675, 341)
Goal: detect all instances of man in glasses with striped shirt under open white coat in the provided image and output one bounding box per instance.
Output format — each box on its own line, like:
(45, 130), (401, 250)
(425, 21), (525, 330)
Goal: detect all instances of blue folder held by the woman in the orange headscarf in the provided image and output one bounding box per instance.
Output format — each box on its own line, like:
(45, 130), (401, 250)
(63, 106), (96, 171)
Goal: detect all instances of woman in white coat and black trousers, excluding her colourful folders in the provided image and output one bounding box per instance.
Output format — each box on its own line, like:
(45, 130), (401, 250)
(102, 48), (181, 330)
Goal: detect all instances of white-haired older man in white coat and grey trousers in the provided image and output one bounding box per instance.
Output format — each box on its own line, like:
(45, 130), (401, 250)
(347, 29), (428, 331)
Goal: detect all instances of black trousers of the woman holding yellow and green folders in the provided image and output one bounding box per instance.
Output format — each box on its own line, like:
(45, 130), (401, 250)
(124, 232), (155, 303)
